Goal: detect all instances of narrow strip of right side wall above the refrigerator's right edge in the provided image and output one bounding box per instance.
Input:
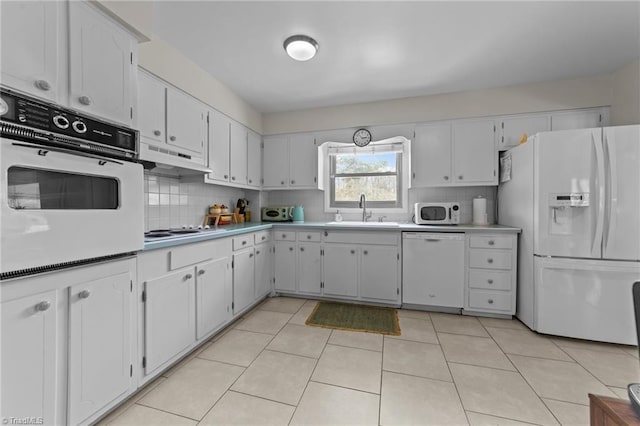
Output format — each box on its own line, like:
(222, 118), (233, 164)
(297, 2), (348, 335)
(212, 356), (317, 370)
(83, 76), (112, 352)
(611, 61), (640, 126)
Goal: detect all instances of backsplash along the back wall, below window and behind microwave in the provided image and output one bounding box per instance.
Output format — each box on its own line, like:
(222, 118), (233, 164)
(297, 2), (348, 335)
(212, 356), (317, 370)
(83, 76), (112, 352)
(263, 186), (497, 223)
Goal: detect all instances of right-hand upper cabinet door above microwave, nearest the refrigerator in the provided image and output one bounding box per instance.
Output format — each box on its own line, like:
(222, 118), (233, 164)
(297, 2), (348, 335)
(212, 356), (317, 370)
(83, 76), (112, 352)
(453, 121), (498, 185)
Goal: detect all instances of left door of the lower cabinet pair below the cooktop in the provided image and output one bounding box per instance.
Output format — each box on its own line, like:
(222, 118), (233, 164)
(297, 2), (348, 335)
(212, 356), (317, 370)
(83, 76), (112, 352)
(144, 268), (196, 374)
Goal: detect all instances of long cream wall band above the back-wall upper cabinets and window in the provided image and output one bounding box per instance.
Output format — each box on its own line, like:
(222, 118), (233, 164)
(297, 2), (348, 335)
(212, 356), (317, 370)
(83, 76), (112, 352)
(263, 75), (612, 135)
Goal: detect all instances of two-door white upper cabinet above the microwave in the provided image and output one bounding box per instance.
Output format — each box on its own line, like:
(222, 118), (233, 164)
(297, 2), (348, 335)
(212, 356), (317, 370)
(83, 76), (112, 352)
(411, 120), (498, 187)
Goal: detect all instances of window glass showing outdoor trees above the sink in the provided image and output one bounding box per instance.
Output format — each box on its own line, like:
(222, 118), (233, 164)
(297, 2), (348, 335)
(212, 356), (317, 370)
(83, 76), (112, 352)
(334, 152), (398, 204)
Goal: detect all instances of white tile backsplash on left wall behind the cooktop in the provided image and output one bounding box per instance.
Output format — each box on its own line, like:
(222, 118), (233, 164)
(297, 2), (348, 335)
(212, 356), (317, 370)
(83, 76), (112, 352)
(144, 172), (260, 231)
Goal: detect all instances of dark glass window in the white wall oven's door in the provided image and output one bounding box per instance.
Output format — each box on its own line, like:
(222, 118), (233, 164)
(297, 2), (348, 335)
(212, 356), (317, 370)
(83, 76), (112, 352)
(7, 166), (120, 210)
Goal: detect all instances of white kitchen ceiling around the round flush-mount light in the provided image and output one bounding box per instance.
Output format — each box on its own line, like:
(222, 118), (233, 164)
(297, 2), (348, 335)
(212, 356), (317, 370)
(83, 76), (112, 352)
(153, 1), (640, 112)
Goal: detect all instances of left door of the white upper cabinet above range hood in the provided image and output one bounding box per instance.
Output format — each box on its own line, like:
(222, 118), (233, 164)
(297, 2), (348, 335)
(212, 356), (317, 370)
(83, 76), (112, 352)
(138, 71), (166, 145)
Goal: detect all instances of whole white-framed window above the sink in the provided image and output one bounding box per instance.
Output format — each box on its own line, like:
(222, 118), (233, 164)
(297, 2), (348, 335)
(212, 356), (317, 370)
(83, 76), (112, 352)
(321, 137), (410, 212)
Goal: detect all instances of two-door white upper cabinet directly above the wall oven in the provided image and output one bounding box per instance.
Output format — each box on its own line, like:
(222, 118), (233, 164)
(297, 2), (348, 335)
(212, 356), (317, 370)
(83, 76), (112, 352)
(1, 1), (137, 126)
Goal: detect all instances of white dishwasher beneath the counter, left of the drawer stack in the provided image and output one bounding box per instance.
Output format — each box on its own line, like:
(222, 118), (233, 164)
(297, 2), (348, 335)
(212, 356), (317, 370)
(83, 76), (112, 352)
(402, 232), (464, 308)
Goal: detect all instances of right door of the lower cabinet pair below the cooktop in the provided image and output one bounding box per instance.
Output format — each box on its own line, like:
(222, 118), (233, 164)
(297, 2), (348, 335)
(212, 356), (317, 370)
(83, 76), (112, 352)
(196, 257), (231, 339)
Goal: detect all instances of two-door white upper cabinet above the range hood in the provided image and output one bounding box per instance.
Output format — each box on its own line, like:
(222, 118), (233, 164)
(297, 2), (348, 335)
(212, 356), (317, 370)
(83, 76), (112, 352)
(138, 70), (206, 165)
